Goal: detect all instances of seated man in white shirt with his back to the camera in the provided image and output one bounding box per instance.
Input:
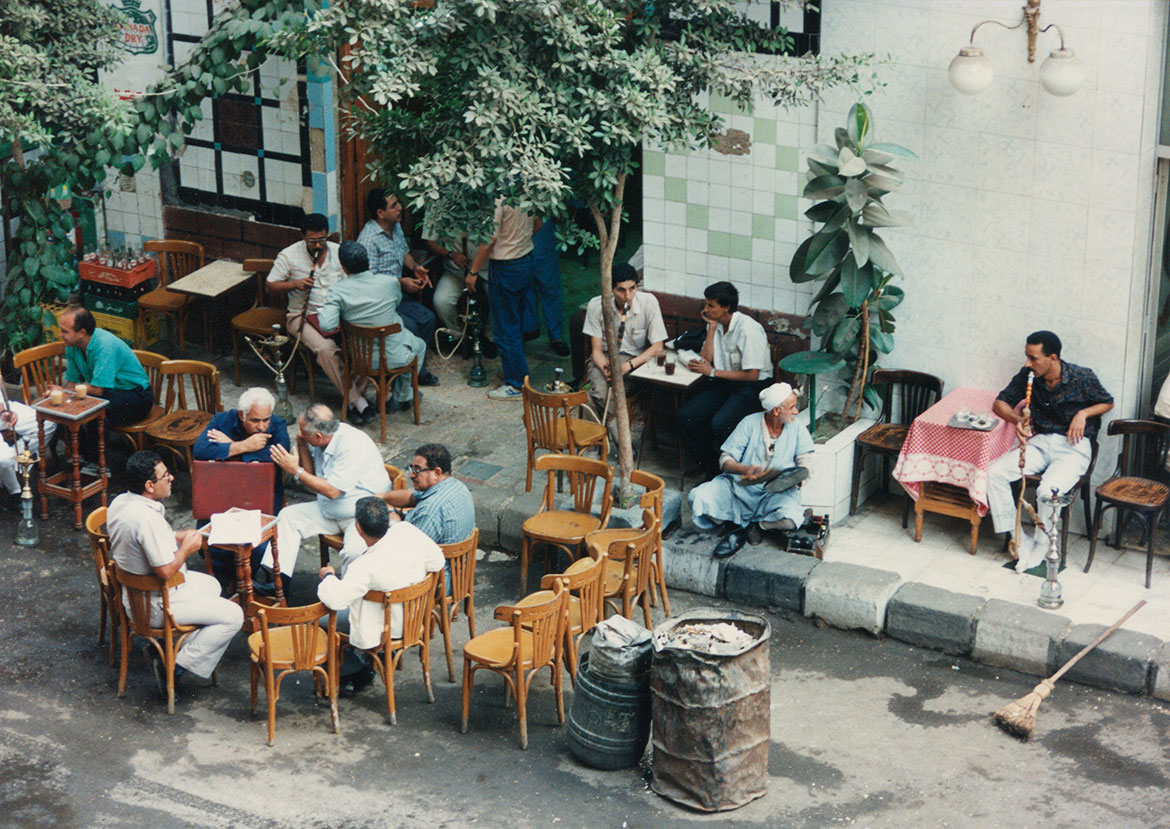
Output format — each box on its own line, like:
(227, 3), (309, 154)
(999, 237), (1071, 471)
(317, 498), (446, 692)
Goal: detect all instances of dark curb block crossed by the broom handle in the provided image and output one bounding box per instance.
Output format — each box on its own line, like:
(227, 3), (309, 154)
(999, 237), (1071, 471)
(1057, 624), (1162, 693)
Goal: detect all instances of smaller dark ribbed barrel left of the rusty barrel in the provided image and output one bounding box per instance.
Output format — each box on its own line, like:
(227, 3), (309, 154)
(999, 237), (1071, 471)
(569, 654), (651, 769)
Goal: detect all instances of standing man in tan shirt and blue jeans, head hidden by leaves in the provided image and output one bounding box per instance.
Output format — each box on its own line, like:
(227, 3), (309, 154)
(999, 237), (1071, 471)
(467, 198), (541, 400)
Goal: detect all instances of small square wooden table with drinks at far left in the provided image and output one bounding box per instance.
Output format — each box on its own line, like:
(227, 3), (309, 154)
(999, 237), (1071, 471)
(33, 392), (110, 530)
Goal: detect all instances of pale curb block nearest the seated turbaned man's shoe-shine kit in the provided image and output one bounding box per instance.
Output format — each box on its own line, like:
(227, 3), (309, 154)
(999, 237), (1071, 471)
(804, 561), (902, 636)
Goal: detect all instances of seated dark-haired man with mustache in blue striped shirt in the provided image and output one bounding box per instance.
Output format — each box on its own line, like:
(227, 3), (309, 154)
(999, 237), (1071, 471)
(381, 443), (475, 544)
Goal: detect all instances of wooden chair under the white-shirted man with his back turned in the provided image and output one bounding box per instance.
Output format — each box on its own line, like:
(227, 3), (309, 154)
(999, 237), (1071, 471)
(353, 572), (442, 725)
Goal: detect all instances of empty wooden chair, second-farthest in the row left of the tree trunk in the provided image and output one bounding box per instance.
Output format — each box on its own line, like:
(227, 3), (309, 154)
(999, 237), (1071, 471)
(519, 455), (613, 589)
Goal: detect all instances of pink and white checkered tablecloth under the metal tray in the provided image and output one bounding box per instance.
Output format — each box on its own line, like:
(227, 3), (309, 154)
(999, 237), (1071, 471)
(894, 386), (1016, 516)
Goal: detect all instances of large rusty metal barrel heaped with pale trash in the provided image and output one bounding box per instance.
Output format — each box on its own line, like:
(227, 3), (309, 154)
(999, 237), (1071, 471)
(651, 608), (772, 811)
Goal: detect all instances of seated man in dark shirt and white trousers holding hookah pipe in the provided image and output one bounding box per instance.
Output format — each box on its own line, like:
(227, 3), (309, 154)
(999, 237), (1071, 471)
(987, 331), (1113, 572)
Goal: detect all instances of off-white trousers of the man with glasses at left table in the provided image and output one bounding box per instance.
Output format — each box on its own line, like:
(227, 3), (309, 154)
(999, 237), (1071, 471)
(126, 569), (243, 679)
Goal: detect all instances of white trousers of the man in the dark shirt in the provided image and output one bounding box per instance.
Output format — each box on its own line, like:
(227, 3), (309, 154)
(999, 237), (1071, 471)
(987, 435), (1093, 569)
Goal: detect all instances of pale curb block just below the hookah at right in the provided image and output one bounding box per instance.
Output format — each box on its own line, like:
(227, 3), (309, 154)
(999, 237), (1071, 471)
(971, 599), (1068, 676)
